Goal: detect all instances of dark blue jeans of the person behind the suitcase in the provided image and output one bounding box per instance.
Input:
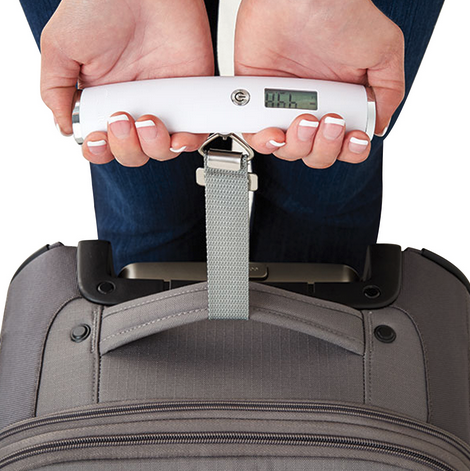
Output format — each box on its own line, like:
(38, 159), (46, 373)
(21, 0), (444, 271)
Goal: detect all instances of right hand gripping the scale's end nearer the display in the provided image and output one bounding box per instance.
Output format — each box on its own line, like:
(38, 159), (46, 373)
(235, 0), (404, 168)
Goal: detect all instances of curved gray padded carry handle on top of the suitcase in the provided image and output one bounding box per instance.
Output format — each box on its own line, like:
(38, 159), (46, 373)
(100, 283), (364, 355)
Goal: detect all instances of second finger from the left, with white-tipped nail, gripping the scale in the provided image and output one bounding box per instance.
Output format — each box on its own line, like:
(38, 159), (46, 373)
(108, 112), (149, 167)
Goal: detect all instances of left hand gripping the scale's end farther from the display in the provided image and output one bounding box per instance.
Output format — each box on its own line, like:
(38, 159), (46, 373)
(41, 0), (214, 166)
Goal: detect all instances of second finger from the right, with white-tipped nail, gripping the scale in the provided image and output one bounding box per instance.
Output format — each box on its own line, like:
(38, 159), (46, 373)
(302, 114), (346, 168)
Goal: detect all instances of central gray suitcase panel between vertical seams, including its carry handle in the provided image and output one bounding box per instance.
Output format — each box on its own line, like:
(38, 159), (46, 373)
(99, 283), (364, 403)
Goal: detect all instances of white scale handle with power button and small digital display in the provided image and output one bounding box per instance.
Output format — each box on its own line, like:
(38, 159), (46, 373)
(72, 76), (376, 144)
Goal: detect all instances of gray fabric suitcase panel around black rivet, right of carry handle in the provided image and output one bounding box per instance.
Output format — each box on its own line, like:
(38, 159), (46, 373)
(364, 308), (428, 422)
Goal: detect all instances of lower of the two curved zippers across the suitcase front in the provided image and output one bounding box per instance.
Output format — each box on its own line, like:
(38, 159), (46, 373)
(0, 432), (455, 471)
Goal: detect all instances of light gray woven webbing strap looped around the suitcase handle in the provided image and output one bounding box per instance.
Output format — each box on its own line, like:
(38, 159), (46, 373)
(204, 156), (250, 319)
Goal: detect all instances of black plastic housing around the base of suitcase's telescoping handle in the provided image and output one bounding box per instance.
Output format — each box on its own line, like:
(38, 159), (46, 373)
(77, 240), (402, 309)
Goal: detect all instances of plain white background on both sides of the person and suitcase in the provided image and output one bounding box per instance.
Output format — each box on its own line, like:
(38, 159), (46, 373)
(0, 0), (470, 318)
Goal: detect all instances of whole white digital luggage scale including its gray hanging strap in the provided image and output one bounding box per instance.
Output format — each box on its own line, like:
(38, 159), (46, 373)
(72, 76), (376, 319)
